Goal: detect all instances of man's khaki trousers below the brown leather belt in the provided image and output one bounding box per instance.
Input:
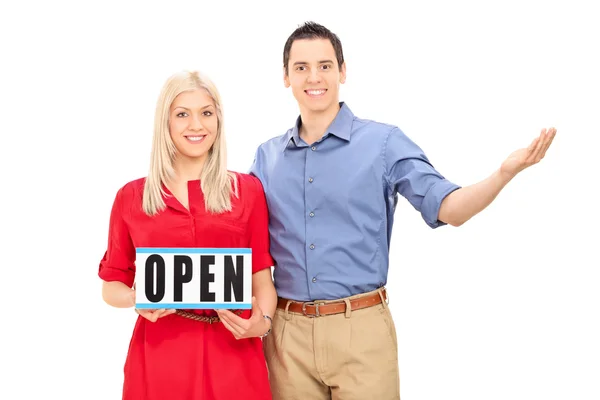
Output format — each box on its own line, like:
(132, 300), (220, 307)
(264, 293), (400, 400)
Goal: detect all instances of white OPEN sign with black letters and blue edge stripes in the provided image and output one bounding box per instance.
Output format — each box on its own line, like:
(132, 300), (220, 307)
(135, 247), (252, 309)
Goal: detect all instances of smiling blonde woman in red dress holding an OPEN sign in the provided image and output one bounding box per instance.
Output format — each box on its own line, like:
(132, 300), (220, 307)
(99, 72), (277, 400)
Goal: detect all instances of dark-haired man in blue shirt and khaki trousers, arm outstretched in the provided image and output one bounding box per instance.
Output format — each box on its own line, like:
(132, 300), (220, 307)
(250, 22), (556, 400)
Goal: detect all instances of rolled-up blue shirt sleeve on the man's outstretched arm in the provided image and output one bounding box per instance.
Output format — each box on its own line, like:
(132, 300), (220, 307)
(384, 128), (460, 228)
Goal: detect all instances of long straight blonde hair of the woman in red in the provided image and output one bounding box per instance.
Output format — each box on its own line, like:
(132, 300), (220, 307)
(142, 71), (237, 216)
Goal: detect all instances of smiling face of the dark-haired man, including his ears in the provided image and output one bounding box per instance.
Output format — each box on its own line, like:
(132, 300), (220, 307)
(284, 39), (346, 112)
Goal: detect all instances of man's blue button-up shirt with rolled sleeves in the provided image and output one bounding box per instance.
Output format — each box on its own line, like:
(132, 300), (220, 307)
(250, 103), (459, 301)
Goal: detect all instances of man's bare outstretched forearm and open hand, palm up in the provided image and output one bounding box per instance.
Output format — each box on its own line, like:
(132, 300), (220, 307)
(438, 128), (556, 226)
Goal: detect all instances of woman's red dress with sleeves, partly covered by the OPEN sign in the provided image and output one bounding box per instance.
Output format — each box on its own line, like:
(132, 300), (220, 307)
(98, 173), (273, 400)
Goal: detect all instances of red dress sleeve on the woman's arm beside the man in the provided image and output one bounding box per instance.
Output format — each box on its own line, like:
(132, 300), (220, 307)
(248, 176), (275, 274)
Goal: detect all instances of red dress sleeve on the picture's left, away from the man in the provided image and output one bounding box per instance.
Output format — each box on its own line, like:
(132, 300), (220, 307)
(98, 188), (135, 287)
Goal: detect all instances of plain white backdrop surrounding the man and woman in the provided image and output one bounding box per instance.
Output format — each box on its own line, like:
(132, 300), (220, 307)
(0, 0), (600, 400)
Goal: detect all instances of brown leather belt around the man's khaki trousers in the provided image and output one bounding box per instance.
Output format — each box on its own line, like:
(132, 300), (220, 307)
(277, 289), (387, 317)
